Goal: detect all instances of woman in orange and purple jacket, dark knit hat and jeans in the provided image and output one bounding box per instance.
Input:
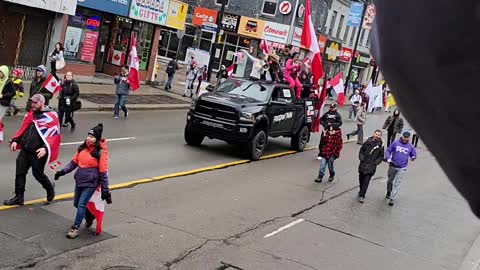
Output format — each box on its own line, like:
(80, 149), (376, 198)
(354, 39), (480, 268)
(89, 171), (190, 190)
(55, 124), (112, 239)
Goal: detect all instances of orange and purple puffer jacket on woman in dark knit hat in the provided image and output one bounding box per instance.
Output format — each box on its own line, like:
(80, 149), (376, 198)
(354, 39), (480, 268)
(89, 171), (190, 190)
(62, 139), (108, 191)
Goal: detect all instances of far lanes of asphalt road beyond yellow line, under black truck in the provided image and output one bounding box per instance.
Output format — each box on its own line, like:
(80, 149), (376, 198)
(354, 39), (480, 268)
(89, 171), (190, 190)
(0, 109), (386, 201)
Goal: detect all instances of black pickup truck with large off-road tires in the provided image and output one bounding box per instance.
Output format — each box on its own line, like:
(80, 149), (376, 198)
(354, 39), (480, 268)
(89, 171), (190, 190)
(184, 78), (314, 160)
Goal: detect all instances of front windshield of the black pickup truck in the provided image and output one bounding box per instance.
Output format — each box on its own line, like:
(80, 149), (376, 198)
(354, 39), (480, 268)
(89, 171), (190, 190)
(216, 79), (272, 102)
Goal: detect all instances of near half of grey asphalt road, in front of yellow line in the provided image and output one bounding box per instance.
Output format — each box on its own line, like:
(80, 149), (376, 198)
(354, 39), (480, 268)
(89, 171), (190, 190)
(0, 111), (480, 270)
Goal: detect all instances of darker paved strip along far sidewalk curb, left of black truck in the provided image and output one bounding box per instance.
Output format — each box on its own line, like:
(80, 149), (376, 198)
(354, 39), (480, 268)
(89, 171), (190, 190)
(80, 94), (188, 105)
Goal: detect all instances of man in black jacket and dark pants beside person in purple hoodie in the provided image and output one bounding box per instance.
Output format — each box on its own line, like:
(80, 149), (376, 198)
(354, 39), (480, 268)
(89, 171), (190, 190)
(358, 129), (385, 203)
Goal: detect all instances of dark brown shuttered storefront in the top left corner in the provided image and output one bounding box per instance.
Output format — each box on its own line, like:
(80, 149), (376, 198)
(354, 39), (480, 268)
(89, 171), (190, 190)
(0, 0), (76, 78)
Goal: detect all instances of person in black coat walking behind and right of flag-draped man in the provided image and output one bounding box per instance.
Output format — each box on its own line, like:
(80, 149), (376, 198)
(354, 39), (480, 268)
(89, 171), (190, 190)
(58, 71), (80, 130)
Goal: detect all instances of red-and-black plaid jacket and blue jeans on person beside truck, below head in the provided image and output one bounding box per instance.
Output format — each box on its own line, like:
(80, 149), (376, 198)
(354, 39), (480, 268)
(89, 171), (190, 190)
(315, 127), (343, 183)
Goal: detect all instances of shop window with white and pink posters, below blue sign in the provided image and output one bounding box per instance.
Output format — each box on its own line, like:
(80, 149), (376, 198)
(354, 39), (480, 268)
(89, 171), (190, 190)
(64, 8), (105, 63)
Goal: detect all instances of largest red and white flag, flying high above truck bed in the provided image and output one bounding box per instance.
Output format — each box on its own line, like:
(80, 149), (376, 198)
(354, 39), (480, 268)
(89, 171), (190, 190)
(300, 0), (323, 87)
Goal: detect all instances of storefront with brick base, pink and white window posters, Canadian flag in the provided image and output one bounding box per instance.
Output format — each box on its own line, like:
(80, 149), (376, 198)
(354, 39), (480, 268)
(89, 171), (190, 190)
(63, 0), (161, 80)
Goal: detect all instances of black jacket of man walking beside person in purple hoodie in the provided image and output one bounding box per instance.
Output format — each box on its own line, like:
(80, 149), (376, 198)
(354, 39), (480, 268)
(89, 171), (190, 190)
(358, 137), (385, 175)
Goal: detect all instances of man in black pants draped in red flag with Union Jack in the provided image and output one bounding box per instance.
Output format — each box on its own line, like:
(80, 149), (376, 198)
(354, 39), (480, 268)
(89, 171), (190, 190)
(3, 94), (61, 205)
